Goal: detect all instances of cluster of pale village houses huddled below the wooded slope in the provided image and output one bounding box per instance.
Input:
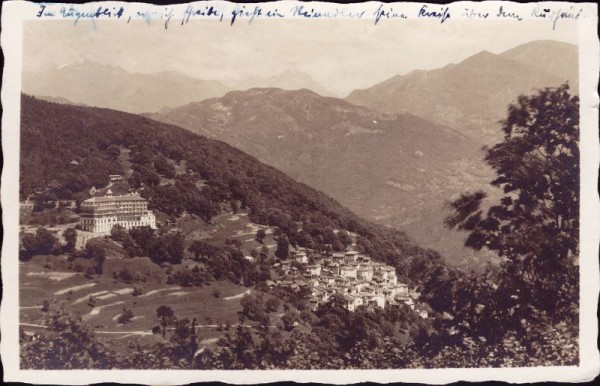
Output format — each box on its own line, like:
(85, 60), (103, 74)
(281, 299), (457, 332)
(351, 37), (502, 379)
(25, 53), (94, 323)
(267, 248), (428, 318)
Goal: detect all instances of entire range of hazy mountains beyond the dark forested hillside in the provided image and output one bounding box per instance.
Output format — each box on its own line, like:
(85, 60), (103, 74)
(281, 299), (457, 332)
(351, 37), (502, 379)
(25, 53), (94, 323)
(24, 41), (578, 267)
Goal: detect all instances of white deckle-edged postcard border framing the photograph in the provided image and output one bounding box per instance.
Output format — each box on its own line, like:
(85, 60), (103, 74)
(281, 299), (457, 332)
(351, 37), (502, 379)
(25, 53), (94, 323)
(0, 1), (600, 384)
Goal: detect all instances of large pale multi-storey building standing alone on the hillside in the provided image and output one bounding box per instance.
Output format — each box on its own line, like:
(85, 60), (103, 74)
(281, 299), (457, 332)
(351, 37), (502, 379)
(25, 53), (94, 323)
(80, 193), (156, 233)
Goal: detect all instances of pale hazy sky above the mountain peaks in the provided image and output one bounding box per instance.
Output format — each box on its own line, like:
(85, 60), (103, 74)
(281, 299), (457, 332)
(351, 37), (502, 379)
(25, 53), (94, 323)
(23, 20), (577, 96)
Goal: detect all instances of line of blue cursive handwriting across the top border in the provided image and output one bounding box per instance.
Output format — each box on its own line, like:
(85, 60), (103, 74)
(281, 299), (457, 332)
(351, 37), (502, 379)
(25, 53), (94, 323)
(34, 1), (584, 29)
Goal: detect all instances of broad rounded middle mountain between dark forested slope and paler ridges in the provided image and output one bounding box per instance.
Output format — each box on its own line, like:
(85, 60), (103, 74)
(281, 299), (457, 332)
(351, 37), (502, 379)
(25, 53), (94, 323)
(149, 89), (496, 263)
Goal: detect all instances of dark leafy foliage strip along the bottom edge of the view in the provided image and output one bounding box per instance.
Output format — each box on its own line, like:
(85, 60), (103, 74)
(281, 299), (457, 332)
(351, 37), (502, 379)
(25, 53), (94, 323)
(21, 302), (578, 369)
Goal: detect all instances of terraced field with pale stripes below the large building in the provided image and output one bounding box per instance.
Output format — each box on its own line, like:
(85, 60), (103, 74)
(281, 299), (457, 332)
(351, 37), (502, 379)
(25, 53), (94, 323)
(19, 256), (277, 352)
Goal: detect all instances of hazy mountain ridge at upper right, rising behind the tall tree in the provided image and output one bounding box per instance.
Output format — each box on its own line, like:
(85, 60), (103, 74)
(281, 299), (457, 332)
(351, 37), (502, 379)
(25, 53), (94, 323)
(346, 41), (579, 145)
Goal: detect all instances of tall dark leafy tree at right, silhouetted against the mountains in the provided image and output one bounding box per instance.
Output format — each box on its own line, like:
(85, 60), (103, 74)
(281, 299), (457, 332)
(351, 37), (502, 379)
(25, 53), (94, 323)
(446, 84), (579, 319)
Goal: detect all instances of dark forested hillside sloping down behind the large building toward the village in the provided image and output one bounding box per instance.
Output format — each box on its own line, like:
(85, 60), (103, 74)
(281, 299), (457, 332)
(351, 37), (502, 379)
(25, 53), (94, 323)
(20, 96), (446, 284)
